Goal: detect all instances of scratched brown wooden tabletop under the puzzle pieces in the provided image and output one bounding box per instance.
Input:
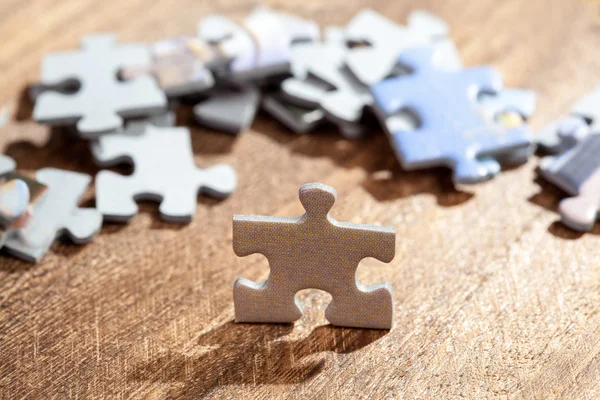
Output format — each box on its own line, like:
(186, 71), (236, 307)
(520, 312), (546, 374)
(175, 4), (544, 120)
(0, 0), (600, 399)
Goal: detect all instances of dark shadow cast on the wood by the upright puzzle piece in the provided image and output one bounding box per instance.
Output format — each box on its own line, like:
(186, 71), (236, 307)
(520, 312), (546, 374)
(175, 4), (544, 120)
(129, 321), (388, 398)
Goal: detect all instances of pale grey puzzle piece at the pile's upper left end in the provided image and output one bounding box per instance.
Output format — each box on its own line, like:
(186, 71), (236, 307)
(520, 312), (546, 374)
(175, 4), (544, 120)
(33, 34), (167, 137)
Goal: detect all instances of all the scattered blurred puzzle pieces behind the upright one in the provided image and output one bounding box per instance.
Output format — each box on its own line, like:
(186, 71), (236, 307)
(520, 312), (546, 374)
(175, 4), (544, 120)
(0, 7), (599, 261)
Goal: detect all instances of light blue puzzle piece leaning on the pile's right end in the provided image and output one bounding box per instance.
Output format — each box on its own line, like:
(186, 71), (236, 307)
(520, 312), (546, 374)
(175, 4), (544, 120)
(371, 48), (531, 183)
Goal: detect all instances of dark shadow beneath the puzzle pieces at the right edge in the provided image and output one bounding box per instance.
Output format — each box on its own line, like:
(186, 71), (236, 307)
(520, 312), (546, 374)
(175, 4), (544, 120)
(527, 176), (600, 240)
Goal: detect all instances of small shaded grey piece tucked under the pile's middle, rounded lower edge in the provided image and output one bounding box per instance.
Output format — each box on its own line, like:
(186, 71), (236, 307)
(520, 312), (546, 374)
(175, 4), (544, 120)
(194, 86), (260, 133)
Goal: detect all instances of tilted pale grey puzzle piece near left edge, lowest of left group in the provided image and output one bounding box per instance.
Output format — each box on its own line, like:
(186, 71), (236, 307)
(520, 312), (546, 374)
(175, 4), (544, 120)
(4, 168), (102, 262)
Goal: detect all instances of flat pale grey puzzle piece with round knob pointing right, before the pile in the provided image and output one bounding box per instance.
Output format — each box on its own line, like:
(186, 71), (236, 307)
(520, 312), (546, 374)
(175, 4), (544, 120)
(92, 115), (236, 222)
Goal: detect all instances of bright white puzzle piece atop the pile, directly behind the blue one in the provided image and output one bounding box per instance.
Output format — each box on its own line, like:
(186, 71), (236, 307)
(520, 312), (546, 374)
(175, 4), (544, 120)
(344, 9), (450, 85)
